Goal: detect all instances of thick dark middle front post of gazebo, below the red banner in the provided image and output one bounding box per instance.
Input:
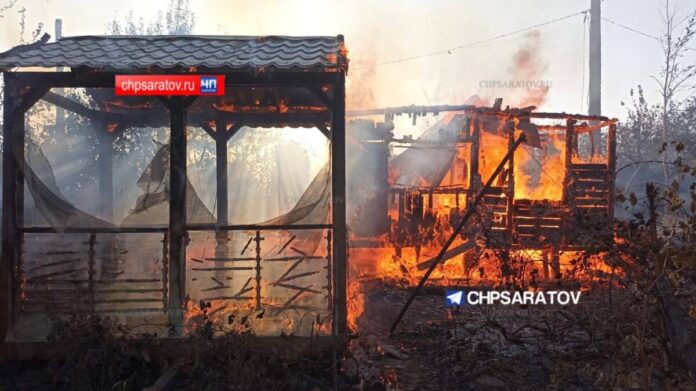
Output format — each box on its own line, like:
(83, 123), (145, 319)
(168, 97), (190, 333)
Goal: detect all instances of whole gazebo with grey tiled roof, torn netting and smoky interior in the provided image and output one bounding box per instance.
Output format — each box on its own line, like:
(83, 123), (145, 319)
(0, 32), (348, 343)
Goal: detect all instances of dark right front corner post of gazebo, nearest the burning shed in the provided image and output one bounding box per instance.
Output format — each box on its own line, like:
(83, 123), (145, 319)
(331, 73), (348, 340)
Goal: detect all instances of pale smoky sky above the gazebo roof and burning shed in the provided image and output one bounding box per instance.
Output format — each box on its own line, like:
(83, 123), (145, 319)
(0, 0), (696, 125)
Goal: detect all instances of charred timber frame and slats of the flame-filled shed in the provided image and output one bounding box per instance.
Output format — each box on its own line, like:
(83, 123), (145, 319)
(347, 105), (618, 254)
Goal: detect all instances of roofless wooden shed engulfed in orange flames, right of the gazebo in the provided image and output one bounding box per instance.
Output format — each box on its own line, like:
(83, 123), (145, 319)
(348, 100), (616, 282)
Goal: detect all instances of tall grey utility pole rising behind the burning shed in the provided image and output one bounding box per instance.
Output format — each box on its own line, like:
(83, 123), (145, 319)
(588, 0), (602, 154)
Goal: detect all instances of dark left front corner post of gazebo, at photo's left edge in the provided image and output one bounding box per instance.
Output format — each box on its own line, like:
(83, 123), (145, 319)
(0, 73), (24, 341)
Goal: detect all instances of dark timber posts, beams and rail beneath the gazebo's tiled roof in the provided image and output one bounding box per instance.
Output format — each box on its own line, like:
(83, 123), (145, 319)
(0, 68), (348, 348)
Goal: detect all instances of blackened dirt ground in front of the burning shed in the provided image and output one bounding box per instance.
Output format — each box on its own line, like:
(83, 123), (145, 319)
(345, 280), (696, 390)
